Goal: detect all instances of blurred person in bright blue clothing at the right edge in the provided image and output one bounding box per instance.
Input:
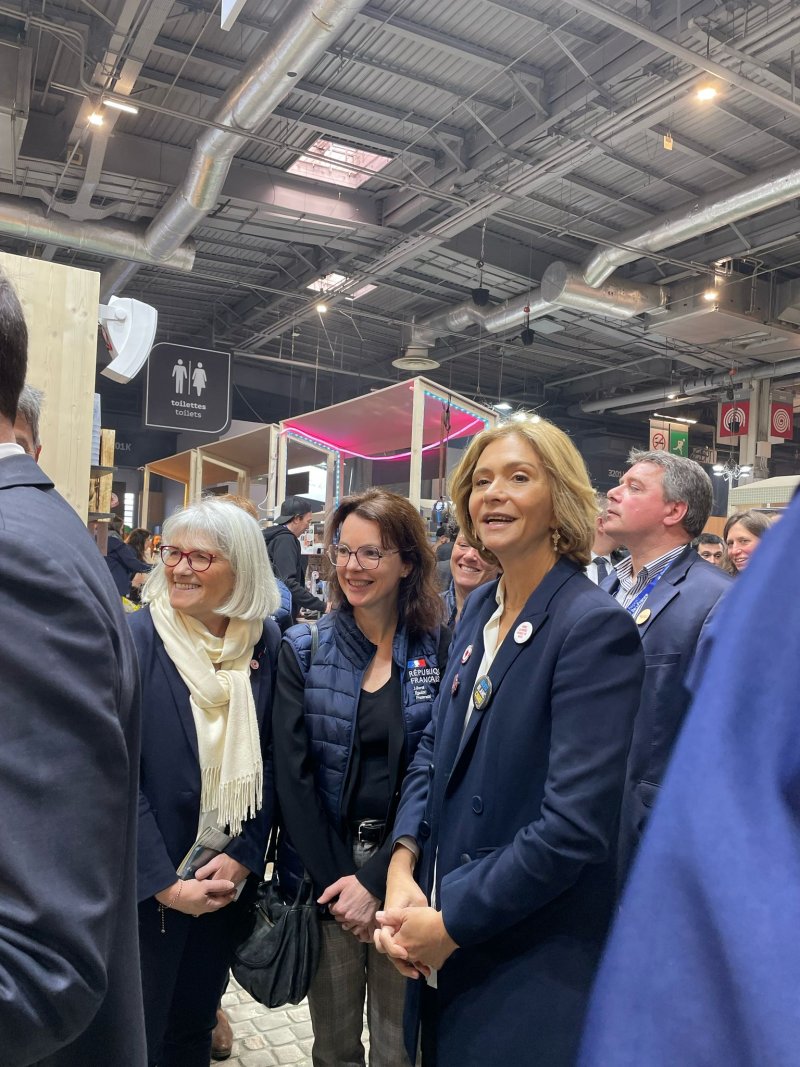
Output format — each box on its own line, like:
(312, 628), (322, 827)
(579, 497), (800, 1067)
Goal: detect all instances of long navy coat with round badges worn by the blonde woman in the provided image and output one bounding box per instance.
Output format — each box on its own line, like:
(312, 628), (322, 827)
(394, 559), (644, 1067)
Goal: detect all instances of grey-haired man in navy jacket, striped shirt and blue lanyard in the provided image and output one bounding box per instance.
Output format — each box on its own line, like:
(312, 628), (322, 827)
(603, 449), (731, 879)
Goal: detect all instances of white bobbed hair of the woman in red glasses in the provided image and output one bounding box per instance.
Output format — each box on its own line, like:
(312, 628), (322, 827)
(142, 496), (281, 620)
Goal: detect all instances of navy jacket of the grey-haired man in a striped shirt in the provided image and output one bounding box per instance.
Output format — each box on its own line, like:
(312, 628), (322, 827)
(603, 545), (731, 883)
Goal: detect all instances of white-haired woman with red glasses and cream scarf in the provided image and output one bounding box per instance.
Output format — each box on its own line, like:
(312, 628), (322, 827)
(129, 498), (279, 1067)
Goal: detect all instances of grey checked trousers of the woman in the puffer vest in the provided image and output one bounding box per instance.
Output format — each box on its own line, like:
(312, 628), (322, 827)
(308, 844), (409, 1067)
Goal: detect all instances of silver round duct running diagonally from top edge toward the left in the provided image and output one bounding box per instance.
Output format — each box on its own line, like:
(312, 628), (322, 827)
(100, 0), (367, 300)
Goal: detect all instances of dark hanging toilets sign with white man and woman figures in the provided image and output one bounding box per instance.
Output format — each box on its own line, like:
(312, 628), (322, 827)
(144, 343), (230, 434)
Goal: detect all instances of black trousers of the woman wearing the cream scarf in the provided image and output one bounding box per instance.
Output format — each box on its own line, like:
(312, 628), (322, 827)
(139, 897), (242, 1067)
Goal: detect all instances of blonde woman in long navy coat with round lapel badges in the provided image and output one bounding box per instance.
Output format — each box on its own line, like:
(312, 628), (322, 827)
(375, 418), (644, 1067)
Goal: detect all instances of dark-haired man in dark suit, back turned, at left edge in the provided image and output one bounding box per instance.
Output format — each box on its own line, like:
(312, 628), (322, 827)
(0, 275), (145, 1067)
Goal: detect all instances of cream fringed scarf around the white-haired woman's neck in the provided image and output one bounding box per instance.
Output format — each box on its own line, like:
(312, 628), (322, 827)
(150, 595), (263, 834)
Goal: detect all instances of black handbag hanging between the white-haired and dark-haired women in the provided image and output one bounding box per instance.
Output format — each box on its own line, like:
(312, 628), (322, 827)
(230, 832), (320, 1007)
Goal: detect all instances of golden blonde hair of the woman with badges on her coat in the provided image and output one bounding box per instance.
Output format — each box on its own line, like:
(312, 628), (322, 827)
(450, 415), (598, 567)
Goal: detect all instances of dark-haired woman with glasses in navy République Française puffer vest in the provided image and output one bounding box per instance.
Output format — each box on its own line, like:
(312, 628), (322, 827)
(273, 489), (449, 1067)
